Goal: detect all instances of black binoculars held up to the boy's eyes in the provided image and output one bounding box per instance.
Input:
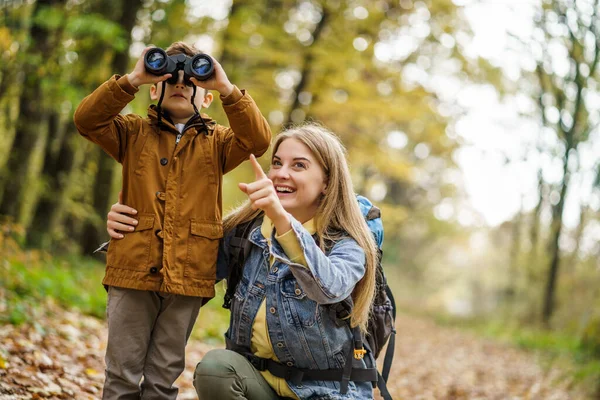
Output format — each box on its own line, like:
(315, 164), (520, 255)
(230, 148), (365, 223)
(144, 47), (214, 86)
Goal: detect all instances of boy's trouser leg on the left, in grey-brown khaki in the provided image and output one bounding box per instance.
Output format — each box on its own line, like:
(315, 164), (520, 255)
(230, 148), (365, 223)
(102, 286), (159, 400)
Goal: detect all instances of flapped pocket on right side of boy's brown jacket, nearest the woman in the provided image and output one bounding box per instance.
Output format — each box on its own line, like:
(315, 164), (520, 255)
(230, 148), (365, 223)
(184, 219), (223, 279)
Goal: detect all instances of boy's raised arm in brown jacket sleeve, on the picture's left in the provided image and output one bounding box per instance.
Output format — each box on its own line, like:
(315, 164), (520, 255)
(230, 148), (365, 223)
(73, 75), (140, 162)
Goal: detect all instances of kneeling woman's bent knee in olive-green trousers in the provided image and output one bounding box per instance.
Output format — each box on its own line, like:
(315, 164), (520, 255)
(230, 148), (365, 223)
(194, 349), (279, 400)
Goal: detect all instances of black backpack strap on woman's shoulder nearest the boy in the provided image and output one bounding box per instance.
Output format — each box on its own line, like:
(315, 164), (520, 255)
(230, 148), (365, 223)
(223, 215), (262, 309)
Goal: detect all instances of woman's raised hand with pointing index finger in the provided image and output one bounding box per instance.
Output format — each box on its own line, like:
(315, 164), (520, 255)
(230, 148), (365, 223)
(238, 154), (292, 235)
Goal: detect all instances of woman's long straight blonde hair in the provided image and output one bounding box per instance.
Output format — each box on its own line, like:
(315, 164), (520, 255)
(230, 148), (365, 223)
(223, 123), (377, 332)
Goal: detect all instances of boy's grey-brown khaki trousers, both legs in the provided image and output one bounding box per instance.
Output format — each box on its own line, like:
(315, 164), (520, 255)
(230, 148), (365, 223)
(102, 286), (203, 400)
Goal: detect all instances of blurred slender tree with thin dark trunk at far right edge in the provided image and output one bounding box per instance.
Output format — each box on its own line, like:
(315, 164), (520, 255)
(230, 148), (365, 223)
(524, 0), (600, 324)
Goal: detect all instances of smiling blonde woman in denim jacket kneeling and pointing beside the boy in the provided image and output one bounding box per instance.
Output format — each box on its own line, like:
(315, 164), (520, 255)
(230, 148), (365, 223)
(108, 124), (377, 400)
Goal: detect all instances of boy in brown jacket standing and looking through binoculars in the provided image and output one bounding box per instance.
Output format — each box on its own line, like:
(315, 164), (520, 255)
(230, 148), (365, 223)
(74, 42), (271, 400)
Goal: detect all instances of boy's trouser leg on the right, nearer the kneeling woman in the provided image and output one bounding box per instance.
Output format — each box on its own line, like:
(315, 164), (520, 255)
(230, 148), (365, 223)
(141, 293), (204, 400)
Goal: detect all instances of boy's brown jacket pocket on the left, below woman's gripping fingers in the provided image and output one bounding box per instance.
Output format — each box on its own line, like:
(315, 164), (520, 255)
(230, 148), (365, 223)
(106, 214), (154, 271)
